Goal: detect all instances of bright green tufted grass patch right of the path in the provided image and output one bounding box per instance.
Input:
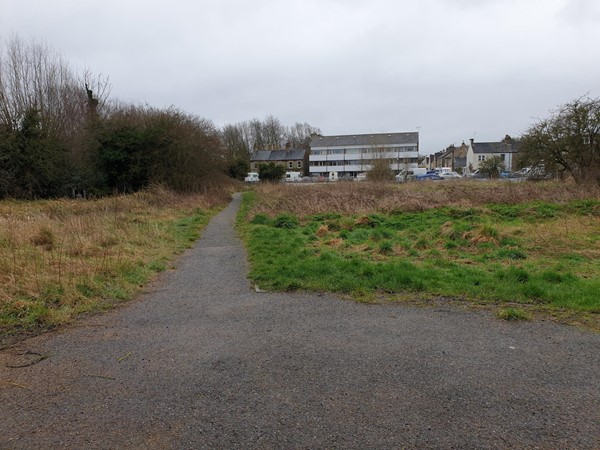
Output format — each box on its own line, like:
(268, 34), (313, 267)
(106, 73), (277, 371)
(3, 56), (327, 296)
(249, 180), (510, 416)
(238, 193), (600, 313)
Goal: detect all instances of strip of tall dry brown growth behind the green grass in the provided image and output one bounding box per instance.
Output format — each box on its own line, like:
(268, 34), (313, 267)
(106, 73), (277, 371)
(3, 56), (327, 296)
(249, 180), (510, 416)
(252, 180), (600, 217)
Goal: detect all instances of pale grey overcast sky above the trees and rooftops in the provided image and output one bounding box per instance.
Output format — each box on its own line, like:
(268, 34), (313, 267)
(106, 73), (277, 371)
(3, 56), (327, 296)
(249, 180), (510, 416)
(0, 0), (600, 154)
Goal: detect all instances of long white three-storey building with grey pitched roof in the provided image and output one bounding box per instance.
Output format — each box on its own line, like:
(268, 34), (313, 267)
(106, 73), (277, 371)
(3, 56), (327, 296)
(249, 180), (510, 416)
(309, 132), (419, 177)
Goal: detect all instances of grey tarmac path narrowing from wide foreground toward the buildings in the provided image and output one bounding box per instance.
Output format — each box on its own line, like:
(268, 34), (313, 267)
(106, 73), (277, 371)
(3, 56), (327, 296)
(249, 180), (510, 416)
(0, 197), (600, 449)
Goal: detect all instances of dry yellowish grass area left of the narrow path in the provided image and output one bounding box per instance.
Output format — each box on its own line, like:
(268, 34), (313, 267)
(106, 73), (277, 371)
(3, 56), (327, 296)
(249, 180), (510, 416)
(0, 189), (228, 335)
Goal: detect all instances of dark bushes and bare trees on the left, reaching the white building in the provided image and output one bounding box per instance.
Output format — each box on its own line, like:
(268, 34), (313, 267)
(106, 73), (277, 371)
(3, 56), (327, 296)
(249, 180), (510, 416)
(0, 37), (318, 199)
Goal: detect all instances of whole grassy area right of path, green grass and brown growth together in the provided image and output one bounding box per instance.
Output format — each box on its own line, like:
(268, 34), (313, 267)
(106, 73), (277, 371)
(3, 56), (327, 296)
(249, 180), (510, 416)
(240, 182), (600, 328)
